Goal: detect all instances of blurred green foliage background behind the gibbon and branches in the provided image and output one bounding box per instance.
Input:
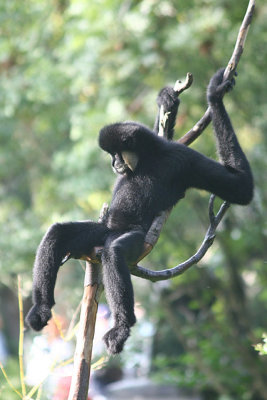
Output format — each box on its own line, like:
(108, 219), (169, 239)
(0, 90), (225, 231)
(0, 0), (267, 400)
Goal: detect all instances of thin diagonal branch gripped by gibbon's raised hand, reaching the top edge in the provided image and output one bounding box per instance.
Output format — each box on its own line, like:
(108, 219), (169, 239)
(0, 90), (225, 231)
(178, 0), (255, 146)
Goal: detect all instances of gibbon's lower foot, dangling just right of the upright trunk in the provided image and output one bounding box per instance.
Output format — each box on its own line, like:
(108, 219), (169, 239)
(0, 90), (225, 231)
(103, 325), (130, 354)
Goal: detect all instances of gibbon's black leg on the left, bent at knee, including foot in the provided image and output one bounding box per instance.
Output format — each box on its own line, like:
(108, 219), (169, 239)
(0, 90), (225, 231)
(26, 221), (109, 331)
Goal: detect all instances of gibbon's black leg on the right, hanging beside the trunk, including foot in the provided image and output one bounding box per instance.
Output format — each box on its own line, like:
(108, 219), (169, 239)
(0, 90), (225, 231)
(102, 230), (145, 354)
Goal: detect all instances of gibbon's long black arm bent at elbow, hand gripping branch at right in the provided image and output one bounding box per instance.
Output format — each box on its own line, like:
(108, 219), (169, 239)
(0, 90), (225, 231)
(185, 69), (253, 205)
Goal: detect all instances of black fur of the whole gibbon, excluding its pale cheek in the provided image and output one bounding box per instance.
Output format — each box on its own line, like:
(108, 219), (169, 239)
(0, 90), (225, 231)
(27, 70), (253, 354)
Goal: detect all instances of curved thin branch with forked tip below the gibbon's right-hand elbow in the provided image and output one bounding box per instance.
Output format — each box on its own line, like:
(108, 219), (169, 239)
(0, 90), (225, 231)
(130, 195), (230, 282)
